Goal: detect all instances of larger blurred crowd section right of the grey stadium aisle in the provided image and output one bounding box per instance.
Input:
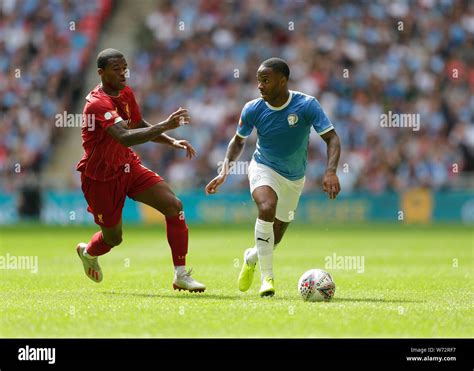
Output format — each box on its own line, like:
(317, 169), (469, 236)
(130, 0), (474, 193)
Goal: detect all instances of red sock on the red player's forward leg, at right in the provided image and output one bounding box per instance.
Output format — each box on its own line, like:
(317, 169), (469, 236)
(166, 214), (188, 266)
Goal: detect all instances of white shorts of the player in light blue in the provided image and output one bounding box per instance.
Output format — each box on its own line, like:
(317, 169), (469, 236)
(248, 160), (306, 223)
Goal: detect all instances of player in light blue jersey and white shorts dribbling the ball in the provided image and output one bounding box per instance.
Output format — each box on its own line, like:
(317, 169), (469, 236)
(206, 58), (341, 297)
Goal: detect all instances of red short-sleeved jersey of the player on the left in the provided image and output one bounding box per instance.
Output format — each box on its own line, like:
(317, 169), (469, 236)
(77, 84), (142, 182)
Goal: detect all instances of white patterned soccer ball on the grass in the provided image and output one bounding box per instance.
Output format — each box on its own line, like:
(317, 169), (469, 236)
(298, 269), (336, 301)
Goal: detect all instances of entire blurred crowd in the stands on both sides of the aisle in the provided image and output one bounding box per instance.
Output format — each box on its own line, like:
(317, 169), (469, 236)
(0, 0), (474, 193)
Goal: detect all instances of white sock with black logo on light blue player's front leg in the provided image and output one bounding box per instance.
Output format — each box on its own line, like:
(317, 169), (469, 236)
(256, 219), (275, 280)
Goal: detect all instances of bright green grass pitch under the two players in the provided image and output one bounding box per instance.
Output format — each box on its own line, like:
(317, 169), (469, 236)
(0, 224), (474, 338)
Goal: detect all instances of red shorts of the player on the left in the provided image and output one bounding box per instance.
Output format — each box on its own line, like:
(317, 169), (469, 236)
(81, 163), (163, 228)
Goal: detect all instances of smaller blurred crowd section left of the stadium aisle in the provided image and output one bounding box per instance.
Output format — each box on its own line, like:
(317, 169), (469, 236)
(0, 0), (112, 191)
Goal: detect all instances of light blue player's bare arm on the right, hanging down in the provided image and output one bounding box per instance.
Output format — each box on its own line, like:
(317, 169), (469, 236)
(321, 130), (341, 200)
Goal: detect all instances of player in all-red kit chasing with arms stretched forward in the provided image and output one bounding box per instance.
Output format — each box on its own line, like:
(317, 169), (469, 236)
(76, 49), (206, 292)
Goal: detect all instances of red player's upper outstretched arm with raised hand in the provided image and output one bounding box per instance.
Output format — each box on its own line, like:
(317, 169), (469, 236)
(107, 108), (189, 147)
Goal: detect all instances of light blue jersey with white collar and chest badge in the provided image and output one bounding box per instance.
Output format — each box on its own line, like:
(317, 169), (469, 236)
(237, 90), (334, 180)
